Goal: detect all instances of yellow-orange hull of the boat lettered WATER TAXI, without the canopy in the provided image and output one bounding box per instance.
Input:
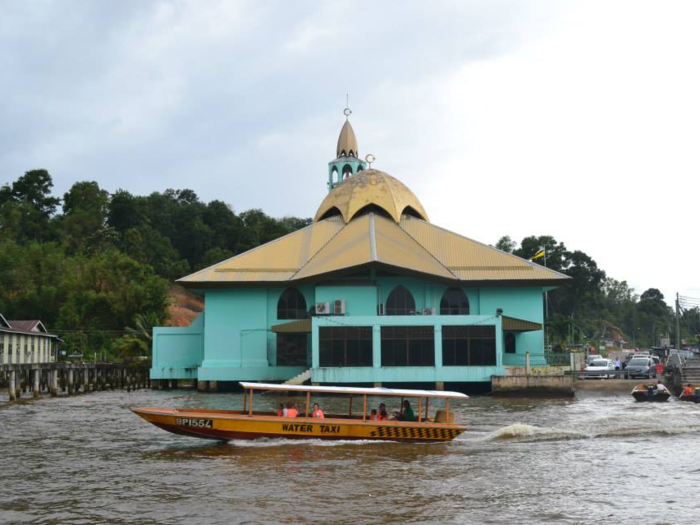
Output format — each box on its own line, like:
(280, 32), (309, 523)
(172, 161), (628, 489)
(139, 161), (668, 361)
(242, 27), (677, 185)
(131, 408), (466, 442)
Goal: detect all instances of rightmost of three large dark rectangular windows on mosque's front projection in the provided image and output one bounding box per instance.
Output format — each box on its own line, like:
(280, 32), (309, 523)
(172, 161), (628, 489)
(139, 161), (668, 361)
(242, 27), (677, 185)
(442, 326), (496, 366)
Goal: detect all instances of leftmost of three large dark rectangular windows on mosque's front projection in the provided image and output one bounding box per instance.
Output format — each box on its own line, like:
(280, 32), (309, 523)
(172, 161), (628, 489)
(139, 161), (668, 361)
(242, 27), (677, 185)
(319, 326), (372, 367)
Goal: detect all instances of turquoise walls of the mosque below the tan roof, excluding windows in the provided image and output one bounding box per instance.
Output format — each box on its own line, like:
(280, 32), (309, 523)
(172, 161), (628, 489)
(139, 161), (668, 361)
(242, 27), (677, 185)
(151, 277), (544, 383)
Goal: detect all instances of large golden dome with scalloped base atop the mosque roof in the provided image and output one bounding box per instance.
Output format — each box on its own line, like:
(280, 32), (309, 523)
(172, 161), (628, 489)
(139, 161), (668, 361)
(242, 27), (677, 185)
(314, 169), (428, 224)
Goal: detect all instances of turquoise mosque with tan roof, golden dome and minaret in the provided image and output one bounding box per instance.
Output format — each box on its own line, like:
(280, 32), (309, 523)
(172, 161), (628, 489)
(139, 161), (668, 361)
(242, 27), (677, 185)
(151, 110), (568, 390)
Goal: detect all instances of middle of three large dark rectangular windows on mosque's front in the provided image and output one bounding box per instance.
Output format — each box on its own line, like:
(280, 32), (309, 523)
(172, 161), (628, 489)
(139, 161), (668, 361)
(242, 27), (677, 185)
(382, 326), (435, 366)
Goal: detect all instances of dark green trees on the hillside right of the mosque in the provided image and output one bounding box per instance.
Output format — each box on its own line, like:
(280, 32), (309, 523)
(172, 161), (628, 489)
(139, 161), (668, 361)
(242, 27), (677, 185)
(495, 235), (700, 348)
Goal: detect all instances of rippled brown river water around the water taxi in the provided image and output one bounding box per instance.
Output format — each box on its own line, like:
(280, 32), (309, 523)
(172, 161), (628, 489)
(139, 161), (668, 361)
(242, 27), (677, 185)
(0, 390), (700, 525)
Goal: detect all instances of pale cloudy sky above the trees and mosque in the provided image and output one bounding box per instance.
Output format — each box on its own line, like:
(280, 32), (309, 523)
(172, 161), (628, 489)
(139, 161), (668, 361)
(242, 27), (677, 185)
(0, 0), (700, 302)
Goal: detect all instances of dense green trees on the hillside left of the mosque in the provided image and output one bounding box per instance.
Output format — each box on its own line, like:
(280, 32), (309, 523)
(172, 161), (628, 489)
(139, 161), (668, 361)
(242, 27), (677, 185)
(0, 169), (311, 356)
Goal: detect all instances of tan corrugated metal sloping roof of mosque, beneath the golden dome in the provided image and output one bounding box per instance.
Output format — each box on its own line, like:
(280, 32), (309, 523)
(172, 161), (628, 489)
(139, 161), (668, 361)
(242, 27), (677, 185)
(179, 213), (568, 286)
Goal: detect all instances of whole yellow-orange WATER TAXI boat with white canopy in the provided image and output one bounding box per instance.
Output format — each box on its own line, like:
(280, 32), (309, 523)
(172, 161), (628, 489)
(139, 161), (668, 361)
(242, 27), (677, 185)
(131, 382), (469, 442)
